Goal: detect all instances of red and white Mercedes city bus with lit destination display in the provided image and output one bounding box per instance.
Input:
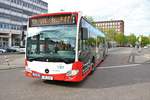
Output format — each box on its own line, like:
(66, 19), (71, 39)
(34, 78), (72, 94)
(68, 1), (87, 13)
(25, 12), (107, 82)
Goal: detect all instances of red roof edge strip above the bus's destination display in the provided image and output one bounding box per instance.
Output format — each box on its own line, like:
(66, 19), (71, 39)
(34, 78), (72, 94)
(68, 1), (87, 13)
(29, 12), (79, 18)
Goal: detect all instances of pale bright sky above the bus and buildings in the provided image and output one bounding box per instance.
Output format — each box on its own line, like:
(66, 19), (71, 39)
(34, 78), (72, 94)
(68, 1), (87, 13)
(44, 0), (150, 35)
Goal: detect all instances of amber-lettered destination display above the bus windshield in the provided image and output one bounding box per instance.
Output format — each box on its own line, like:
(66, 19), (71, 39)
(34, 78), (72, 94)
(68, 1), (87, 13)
(29, 14), (76, 27)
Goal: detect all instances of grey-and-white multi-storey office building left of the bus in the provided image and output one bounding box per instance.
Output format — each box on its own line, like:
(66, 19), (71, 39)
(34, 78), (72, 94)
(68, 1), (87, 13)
(0, 0), (48, 48)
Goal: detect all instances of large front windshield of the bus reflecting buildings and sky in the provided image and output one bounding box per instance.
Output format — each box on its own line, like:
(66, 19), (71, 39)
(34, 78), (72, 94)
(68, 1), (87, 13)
(26, 25), (77, 63)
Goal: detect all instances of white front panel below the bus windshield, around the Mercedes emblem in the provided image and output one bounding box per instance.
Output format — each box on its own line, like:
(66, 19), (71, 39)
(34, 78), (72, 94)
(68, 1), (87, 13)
(26, 61), (72, 74)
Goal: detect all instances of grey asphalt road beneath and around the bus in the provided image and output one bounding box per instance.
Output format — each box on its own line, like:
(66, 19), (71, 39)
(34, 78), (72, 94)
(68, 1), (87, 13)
(0, 48), (150, 100)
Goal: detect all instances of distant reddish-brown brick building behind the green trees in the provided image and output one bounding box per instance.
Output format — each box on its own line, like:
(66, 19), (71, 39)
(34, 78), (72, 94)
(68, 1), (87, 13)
(95, 20), (124, 34)
